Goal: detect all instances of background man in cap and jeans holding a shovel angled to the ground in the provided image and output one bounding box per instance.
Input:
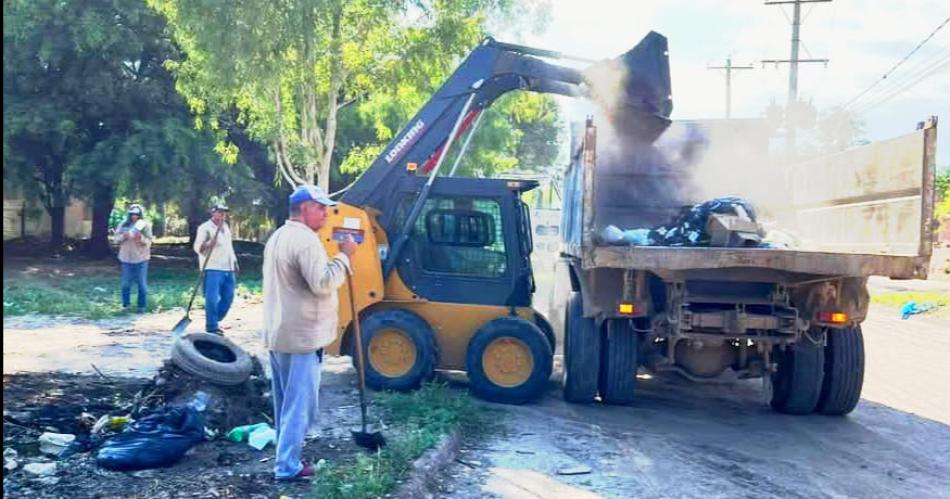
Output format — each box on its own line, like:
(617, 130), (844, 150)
(194, 204), (240, 335)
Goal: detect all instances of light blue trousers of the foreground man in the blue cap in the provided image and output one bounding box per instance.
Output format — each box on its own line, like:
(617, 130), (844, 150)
(270, 352), (323, 478)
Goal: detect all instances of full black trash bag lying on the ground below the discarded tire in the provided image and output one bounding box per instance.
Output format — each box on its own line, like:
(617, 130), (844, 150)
(96, 406), (205, 471)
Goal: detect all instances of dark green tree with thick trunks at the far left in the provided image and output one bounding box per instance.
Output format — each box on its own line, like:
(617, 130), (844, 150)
(3, 0), (184, 256)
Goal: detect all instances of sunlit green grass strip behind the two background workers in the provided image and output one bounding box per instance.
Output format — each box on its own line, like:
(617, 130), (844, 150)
(3, 259), (262, 319)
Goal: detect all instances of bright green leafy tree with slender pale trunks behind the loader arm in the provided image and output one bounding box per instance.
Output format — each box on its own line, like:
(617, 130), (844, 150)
(148, 0), (507, 188)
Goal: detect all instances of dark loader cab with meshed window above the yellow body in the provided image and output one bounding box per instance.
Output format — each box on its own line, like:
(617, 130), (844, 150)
(383, 177), (538, 307)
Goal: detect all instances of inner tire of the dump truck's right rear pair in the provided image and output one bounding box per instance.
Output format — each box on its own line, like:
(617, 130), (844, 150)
(771, 338), (825, 414)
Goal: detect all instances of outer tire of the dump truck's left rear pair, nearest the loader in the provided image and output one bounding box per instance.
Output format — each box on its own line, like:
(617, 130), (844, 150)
(562, 292), (601, 404)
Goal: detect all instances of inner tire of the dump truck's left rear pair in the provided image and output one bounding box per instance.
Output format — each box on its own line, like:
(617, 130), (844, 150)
(599, 319), (640, 405)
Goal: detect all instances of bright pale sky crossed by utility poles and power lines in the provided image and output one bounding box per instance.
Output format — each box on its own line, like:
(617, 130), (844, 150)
(498, 0), (950, 166)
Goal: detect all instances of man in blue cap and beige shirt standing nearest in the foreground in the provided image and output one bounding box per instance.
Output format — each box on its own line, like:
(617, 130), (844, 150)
(263, 185), (356, 480)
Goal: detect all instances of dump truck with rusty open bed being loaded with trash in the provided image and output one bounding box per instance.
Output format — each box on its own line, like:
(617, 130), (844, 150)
(552, 117), (937, 415)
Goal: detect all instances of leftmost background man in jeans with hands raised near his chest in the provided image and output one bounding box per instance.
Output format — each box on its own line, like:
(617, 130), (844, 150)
(112, 204), (152, 314)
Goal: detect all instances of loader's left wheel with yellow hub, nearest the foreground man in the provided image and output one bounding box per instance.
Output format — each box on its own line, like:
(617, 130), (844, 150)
(350, 308), (438, 391)
